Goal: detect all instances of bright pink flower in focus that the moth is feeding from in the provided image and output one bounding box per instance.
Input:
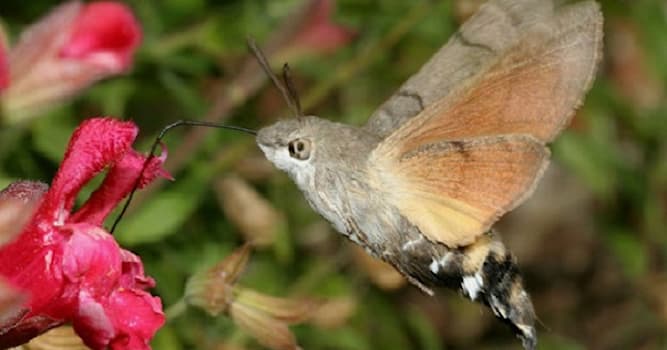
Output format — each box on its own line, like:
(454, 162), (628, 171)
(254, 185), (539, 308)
(0, 118), (168, 349)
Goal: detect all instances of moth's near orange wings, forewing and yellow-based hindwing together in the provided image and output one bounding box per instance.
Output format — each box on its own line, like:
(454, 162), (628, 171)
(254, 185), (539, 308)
(369, 2), (602, 246)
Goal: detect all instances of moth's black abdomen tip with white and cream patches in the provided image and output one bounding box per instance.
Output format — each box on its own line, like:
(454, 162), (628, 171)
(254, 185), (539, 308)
(394, 232), (537, 350)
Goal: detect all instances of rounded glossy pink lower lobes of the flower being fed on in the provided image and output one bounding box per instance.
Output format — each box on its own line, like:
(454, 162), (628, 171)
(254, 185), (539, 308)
(56, 223), (164, 349)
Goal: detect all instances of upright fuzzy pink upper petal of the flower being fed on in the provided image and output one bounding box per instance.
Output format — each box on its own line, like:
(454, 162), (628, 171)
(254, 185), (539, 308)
(37, 118), (138, 226)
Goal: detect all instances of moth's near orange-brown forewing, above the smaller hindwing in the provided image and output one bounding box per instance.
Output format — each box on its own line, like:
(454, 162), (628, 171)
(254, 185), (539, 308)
(384, 2), (602, 151)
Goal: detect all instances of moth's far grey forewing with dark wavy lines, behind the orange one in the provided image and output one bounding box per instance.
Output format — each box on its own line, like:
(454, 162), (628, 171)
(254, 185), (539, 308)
(365, 0), (555, 136)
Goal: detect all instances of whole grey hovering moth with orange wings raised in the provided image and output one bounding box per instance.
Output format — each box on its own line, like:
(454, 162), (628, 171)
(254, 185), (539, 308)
(256, 0), (603, 349)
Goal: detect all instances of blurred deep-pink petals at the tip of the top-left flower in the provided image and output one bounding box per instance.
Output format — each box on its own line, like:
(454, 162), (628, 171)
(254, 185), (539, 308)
(60, 1), (141, 73)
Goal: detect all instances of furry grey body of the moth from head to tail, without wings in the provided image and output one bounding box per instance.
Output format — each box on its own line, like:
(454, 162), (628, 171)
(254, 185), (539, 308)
(257, 117), (537, 348)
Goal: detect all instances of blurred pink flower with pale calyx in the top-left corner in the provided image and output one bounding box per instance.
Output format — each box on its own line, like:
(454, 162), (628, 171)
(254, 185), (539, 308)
(0, 1), (141, 122)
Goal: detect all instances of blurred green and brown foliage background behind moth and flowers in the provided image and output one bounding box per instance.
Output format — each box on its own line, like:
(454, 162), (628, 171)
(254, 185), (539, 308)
(0, 0), (667, 350)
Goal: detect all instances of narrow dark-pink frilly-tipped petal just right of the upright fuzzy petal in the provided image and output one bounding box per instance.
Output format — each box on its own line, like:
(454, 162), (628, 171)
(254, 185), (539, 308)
(71, 149), (169, 225)
